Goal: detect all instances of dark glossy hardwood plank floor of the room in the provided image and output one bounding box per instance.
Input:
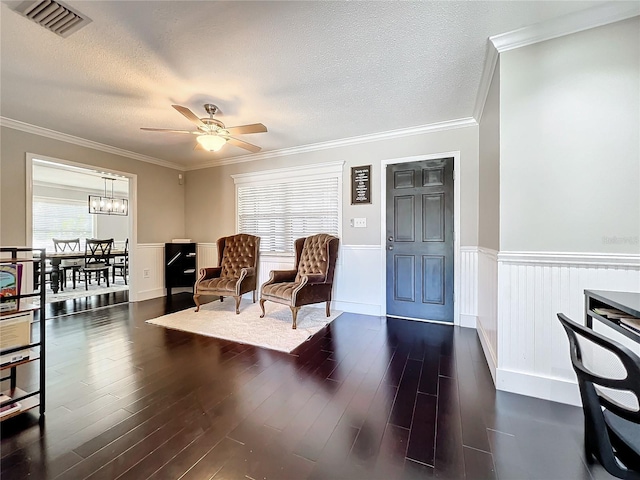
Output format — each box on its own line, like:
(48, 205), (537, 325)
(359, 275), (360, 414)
(0, 294), (609, 480)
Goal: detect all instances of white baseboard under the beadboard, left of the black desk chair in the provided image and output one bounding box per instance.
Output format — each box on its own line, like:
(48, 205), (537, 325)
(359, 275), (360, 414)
(496, 368), (582, 407)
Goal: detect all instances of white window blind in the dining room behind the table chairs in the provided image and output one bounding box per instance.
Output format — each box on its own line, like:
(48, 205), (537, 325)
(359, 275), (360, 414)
(33, 197), (94, 251)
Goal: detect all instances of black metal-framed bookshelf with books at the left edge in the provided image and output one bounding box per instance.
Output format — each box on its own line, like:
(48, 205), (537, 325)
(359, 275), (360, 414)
(0, 247), (46, 421)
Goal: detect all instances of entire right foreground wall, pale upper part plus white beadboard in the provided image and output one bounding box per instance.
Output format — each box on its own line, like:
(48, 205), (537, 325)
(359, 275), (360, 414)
(497, 17), (640, 404)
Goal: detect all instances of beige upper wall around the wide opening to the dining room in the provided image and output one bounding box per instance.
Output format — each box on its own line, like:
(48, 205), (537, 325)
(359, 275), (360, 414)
(0, 127), (185, 245)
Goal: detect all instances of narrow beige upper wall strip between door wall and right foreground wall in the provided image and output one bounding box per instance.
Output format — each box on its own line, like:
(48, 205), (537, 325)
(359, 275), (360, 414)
(478, 57), (500, 250)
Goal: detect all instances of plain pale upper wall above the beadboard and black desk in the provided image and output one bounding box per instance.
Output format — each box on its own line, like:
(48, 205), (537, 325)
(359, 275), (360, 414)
(500, 17), (640, 253)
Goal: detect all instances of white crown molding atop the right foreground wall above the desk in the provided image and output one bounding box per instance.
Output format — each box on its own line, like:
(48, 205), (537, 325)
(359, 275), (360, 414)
(489, 2), (640, 53)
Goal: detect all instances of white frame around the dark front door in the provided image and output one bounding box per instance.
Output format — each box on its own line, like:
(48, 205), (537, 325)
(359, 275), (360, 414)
(380, 150), (462, 325)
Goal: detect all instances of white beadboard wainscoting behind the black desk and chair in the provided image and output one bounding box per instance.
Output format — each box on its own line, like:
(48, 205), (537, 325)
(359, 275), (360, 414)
(498, 252), (640, 405)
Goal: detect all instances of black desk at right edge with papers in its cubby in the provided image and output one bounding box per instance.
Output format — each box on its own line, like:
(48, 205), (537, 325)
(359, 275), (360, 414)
(584, 290), (640, 343)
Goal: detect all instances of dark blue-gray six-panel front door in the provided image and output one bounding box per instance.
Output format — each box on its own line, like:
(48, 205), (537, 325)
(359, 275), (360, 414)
(385, 158), (453, 322)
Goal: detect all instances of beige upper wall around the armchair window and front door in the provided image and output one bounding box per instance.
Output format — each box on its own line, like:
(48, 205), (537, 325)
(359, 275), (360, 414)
(185, 126), (478, 245)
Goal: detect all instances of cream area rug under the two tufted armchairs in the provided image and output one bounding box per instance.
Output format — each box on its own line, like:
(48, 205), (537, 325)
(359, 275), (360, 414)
(147, 298), (342, 353)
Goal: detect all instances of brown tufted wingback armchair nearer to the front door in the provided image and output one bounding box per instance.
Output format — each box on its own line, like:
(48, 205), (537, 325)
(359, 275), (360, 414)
(260, 233), (339, 329)
